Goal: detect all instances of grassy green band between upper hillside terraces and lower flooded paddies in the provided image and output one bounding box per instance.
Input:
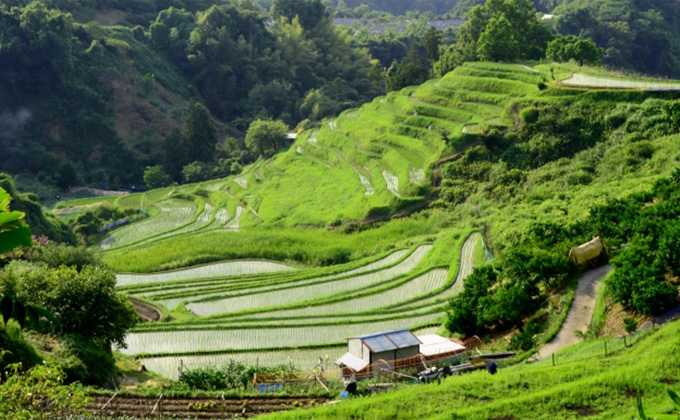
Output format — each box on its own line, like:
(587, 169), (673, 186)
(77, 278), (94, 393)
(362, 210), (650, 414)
(104, 214), (448, 273)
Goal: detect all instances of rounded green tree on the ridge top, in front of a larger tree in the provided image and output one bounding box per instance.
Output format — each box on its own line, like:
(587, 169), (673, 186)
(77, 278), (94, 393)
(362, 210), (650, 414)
(477, 15), (519, 61)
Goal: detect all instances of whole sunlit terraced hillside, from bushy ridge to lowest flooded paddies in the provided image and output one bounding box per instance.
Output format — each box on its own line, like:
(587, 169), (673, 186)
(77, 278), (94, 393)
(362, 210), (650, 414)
(53, 63), (680, 384)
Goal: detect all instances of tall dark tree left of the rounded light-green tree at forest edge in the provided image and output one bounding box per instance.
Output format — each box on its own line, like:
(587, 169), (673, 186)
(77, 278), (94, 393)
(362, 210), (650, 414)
(184, 101), (217, 162)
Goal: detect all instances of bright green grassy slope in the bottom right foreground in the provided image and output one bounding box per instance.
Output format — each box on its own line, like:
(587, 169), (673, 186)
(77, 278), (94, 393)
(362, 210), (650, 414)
(262, 323), (680, 420)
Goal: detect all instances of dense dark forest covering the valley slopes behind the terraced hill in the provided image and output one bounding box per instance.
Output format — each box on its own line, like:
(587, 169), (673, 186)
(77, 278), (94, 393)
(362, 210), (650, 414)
(0, 0), (680, 194)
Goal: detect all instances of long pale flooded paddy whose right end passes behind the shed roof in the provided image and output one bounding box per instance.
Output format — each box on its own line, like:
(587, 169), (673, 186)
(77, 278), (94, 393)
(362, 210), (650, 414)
(120, 313), (441, 355)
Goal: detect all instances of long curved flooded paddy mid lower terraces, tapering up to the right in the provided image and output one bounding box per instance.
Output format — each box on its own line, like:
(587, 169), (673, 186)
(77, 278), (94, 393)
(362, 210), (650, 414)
(187, 245), (432, 316)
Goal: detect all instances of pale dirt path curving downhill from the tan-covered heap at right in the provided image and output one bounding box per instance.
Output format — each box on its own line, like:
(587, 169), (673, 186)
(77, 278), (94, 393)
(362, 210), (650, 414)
(538, 265), (612, 359)
